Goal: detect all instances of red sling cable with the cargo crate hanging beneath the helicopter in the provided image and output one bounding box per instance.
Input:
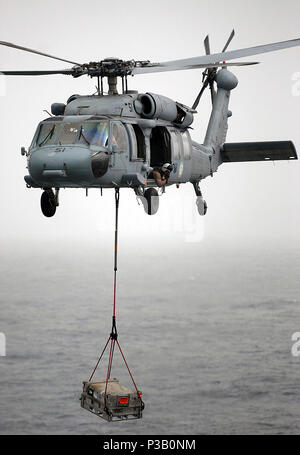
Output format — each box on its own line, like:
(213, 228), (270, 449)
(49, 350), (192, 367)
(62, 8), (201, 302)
(80, 188), (144, 422)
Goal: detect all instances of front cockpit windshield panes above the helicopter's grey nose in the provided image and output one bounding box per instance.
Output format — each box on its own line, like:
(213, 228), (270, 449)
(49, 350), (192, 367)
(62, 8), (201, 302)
(36, 121), (109, 147)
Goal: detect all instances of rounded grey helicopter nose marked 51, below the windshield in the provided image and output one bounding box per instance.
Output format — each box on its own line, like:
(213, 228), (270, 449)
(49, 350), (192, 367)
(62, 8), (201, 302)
(28, 146), (108, 186)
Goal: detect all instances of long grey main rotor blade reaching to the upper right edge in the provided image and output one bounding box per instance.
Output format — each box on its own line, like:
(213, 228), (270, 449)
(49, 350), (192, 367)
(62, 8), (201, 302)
(132, 38), (300, 74)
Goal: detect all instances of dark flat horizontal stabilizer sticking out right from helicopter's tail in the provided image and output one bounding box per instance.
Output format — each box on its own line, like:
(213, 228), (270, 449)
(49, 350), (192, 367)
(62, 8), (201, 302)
(221, 141), (298, 163)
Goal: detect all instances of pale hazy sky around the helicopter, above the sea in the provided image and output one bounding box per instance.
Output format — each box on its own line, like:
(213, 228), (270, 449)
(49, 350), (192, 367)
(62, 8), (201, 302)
(0, 0), (300, 248)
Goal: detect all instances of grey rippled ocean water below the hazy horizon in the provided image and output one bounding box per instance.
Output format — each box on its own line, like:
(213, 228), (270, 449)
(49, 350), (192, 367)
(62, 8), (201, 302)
(0, 243), (300, 435)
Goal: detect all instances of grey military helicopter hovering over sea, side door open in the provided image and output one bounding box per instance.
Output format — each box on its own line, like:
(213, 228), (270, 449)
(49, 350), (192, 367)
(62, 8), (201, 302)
(0, 31), (300, 217)
